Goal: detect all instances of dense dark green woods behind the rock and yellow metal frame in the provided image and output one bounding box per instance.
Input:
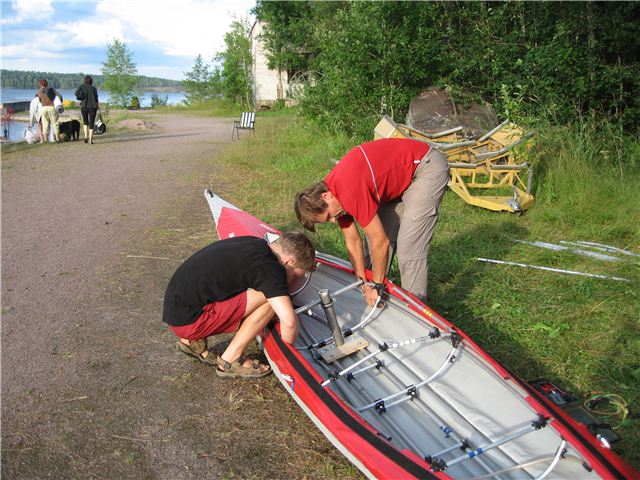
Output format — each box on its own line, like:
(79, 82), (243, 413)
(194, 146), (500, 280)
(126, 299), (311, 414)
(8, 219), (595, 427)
(255, 1), (640, 137)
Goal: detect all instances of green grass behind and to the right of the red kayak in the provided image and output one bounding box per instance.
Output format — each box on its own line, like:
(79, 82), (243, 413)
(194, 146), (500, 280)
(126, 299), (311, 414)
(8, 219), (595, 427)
(205, 112), (640, 466)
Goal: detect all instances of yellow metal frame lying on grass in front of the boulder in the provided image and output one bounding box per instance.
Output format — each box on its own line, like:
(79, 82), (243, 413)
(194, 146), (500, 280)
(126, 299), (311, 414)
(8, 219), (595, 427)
(374, 115), (534, 214)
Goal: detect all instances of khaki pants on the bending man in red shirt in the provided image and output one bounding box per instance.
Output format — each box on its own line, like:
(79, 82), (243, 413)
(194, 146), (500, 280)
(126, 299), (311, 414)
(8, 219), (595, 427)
(365, 148), (449, 301)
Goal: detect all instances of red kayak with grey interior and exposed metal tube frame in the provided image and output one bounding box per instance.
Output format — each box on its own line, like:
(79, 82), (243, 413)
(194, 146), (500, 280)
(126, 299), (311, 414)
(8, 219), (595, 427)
(205, 190), (640, 480)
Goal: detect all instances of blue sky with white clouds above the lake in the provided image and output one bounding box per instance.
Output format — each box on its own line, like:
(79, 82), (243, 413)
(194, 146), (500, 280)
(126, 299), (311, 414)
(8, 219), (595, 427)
(0, 0), (255, 80)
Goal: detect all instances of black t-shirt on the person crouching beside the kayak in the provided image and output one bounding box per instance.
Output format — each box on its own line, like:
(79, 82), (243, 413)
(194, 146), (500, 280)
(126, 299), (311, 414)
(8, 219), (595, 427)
(162, 237), (289, 326)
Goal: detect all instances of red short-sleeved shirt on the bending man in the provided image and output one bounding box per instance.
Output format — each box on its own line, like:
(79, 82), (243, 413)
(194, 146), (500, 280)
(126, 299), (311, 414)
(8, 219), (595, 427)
(324, 138), (430, 228)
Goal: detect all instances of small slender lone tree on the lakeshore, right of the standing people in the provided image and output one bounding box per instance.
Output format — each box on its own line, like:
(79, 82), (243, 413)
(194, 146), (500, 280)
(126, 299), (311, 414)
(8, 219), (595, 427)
(102, 38), (138, 107)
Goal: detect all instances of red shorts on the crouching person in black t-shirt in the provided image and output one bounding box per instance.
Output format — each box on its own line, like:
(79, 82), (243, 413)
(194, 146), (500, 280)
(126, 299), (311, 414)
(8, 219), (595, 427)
(169, 292), (247, 340)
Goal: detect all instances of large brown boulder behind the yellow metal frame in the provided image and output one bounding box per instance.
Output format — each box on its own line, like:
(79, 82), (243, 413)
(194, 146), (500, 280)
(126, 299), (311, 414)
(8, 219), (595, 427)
(406, 87), (500, 138)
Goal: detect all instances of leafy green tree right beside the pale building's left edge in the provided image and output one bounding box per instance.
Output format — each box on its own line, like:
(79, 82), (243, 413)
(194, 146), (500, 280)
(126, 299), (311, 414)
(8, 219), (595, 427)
(214, 20), (253, 110)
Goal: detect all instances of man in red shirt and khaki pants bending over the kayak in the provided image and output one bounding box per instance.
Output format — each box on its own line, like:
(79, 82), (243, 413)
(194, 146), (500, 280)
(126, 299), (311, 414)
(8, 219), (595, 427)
(295, 138), (449, 305)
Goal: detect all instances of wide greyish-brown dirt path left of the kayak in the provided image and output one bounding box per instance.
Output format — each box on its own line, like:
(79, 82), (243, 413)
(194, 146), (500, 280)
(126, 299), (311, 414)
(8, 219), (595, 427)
(1, 113), (357, 479)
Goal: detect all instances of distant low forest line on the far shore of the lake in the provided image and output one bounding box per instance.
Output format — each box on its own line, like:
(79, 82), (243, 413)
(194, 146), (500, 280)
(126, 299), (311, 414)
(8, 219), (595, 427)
(1, 69), (182, 90)
